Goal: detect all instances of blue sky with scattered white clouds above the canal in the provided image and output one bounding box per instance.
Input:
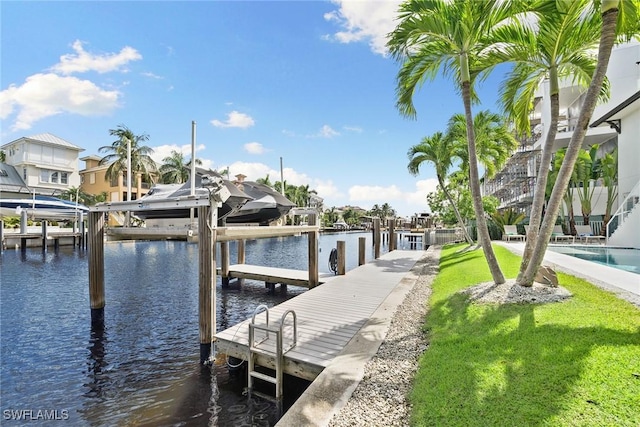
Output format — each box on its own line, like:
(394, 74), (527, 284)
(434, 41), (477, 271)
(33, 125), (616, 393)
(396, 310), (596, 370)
(0, 0), (499, 216)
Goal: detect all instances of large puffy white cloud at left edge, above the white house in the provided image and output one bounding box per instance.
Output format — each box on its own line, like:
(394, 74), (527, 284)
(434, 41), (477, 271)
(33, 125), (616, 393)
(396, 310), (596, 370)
(0, 73), (122, 131)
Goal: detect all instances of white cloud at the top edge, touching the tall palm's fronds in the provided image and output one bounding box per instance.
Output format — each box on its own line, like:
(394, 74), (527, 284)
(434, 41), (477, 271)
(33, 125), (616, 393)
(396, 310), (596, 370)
(324, 0), (400, 55)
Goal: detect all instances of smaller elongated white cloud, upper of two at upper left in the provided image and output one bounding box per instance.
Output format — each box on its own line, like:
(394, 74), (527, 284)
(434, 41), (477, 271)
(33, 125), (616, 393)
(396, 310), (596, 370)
(51, 40), (142, 75)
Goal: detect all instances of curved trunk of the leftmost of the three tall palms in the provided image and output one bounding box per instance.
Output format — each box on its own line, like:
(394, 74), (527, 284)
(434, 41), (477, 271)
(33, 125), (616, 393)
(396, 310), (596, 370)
(462, 79), (505, 285)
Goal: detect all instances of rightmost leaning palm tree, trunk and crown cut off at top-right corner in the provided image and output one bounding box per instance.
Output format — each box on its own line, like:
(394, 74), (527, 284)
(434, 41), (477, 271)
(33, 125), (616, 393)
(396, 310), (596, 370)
(518, 0), (640, 286)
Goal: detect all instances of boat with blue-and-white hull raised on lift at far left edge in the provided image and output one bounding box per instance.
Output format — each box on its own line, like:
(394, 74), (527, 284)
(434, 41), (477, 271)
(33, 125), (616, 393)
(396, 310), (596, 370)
(0, 193), (89, 221)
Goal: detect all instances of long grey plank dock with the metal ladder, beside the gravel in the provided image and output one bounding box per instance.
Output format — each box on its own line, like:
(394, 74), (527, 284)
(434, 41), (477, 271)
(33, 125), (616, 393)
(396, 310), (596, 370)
(216, 250), (424, 381)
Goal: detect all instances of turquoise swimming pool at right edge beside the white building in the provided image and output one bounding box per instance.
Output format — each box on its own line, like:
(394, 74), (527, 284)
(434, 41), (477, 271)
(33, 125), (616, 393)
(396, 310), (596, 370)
(547, 245), (640, 274)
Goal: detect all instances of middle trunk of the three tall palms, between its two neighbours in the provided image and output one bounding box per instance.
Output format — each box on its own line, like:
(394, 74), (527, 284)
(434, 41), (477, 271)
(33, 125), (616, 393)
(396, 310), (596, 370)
(517, 87), (560, 282)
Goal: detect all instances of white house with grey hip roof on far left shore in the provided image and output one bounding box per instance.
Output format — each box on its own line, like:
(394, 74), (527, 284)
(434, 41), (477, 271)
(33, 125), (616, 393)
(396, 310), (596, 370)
(0, 133), (84, 195)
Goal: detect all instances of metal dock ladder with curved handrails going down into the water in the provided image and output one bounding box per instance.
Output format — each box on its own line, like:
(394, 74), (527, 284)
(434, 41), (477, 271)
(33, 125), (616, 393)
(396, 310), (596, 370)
(247, 305), (298, 401)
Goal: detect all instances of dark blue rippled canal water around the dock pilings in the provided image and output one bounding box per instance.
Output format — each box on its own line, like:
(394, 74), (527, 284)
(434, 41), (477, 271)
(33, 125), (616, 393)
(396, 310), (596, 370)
(0, 233), (400, 426)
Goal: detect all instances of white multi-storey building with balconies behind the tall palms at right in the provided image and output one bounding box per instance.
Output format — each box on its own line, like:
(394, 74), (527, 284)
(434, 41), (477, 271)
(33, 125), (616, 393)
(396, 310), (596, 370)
(484, 42), (640, 248)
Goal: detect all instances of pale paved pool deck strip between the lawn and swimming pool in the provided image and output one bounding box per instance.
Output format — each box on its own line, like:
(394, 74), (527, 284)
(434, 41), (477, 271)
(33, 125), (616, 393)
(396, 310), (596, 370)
(494, 241), (640, 307)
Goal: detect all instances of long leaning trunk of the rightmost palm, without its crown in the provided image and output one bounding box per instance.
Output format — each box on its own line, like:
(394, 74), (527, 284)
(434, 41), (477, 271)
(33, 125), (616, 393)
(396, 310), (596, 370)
(519, 7), (618, 286)
